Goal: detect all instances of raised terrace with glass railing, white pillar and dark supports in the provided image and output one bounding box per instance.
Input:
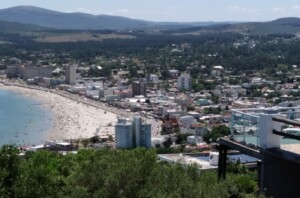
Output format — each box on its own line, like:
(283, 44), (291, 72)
(218, 107), (300, 197)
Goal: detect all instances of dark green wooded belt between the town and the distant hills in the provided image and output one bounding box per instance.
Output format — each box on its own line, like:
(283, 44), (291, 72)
(0, 31), (300, 78)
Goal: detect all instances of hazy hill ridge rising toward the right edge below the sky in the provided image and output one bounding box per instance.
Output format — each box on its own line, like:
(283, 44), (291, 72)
(167, 17), (300, 35)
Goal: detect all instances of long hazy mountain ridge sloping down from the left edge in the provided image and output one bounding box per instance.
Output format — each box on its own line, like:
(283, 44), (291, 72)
(0, 6), (231, 30)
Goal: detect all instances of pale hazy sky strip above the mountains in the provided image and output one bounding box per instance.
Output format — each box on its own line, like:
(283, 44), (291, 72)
(0, 0), (300, 21)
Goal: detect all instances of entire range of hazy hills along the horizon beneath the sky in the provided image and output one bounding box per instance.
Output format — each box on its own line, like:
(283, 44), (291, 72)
(0, 6), (300, 35)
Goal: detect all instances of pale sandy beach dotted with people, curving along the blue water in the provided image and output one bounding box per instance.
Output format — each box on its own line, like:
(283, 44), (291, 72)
(0, 86), (117, 140)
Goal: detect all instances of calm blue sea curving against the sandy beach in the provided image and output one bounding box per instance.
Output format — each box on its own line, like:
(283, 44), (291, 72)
(0, 89), (53, 146)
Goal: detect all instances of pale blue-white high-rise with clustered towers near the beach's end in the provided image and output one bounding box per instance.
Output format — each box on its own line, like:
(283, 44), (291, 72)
(115, 115), (151, 148)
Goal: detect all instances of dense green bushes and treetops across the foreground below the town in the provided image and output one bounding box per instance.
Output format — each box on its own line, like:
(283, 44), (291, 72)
(0, 146), (258, 198)
